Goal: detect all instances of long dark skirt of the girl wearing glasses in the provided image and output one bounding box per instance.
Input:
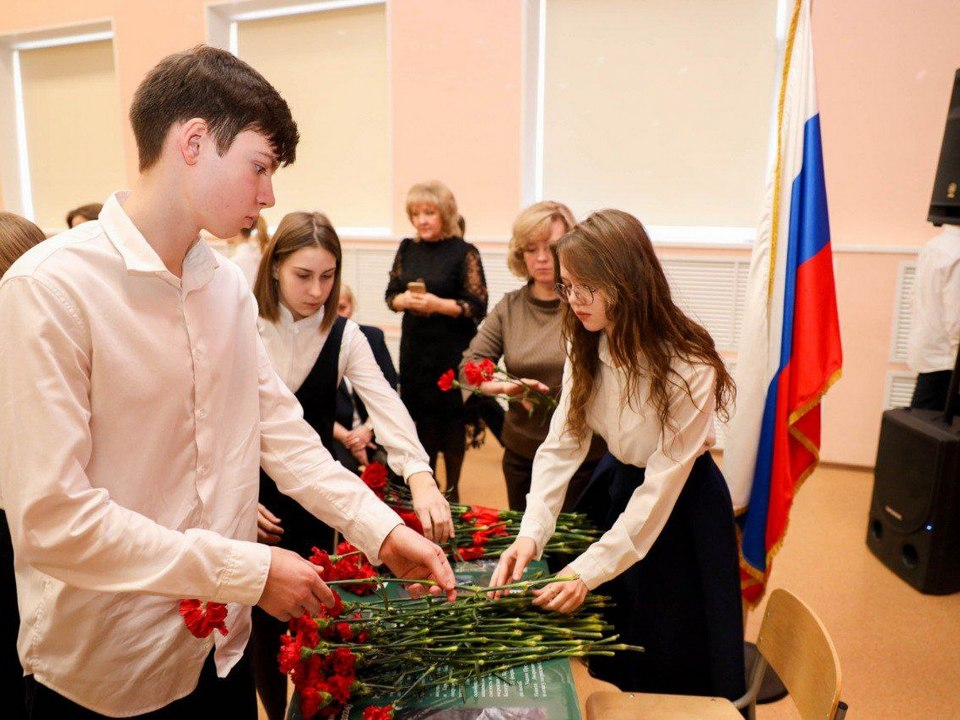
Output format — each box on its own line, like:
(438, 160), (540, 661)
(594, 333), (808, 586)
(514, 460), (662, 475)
(578, 453), (745, 700)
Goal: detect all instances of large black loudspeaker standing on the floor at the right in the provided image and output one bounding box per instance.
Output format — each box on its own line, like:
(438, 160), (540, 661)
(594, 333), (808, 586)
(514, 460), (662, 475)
(867, 408), (960, 595)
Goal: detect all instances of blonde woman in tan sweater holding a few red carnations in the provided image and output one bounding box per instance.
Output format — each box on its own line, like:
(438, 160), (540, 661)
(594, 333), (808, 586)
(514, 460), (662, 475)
(460, 200), (606, 510)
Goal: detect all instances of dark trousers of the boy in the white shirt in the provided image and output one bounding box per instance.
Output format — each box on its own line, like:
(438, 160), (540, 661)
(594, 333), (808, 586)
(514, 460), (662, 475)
(26, 652), (257, 720)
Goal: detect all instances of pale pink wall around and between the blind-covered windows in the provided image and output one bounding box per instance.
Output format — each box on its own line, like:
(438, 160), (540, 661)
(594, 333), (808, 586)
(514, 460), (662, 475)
(0, 0), (960, 465)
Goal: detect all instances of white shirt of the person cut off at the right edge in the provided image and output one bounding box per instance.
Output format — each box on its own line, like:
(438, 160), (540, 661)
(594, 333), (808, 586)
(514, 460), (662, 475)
(907, 225), (960, 373)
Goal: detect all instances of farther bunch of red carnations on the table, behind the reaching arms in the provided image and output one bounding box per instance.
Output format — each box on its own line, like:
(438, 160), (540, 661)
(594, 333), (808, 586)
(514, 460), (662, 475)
(361, 462), (600, 560)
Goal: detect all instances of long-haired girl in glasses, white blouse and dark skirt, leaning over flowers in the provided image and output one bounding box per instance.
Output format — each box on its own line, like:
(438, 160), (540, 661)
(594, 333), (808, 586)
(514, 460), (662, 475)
(491, 210), (744, 698)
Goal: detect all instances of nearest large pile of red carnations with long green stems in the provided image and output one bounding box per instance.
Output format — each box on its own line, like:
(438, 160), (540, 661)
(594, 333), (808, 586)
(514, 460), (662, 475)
(279, 578), (642, 720)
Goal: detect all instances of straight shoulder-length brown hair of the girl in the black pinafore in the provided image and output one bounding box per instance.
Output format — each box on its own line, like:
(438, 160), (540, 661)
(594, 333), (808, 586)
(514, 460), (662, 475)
(253, 212), (343, 330)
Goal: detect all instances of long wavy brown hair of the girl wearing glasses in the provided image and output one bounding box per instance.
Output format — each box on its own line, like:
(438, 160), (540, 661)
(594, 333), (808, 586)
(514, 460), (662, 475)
(557, 210), (735, 439)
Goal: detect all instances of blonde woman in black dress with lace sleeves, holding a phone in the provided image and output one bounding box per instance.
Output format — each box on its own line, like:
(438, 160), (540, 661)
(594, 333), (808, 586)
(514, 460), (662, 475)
(386, 181), (487, 502)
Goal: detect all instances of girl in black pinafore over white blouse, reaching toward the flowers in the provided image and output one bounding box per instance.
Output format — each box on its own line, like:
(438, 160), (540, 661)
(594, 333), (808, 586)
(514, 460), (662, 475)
(253, 212), (453, 720)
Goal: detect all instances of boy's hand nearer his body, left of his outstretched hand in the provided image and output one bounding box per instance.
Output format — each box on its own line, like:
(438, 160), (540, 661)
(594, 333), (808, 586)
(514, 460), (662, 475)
(257, 544), (336, 621)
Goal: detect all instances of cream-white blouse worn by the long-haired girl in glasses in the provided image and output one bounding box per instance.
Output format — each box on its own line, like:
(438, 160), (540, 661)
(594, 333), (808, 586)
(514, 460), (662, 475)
(519, 336), (716, 590)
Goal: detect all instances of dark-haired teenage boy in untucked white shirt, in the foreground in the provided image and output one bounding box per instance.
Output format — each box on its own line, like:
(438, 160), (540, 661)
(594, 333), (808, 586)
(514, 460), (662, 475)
(0, 47), (454, 719)
